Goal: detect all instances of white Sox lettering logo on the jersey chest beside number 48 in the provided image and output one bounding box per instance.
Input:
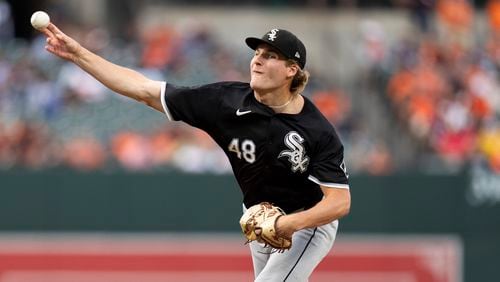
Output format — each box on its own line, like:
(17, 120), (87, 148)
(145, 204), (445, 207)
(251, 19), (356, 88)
(278, 131), (309, 172)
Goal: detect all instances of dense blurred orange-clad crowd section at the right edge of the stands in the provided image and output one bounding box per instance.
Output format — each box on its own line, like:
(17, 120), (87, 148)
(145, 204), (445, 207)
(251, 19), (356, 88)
(385, 0), (500, 173)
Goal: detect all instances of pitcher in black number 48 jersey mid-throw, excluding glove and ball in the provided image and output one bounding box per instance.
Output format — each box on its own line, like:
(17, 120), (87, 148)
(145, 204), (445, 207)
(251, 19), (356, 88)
(42, 24), (350, 281)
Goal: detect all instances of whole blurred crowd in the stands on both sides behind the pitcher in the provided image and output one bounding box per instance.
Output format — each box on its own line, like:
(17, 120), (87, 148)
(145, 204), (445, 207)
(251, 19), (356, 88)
(0, 0), (500, 175)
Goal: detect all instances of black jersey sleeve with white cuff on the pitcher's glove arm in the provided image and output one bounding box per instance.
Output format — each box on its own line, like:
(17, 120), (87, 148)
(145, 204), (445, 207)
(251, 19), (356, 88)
(308, 133), (349, 189)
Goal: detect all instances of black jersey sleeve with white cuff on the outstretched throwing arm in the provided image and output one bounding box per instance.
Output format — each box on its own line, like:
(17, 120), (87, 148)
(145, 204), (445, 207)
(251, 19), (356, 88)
(161, 83), (221, 129)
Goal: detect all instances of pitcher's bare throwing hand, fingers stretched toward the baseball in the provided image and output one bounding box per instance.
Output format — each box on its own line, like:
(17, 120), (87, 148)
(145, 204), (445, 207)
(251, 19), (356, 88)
(42, 23), (82, 62)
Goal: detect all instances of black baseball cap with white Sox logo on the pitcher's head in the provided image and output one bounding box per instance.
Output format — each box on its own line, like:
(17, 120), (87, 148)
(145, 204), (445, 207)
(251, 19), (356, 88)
(245, 28), (306, 69)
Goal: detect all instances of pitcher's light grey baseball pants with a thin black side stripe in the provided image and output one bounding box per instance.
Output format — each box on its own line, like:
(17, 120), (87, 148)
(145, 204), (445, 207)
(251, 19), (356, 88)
(250, 220), (339, 282)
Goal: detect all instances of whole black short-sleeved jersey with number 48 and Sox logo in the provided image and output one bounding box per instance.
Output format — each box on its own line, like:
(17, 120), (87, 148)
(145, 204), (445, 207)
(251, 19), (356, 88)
(161, 82), (349, 212)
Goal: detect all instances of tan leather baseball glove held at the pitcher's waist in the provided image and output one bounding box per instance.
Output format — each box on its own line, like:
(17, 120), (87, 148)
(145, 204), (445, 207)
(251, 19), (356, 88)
(240, 202), (292, 252)
